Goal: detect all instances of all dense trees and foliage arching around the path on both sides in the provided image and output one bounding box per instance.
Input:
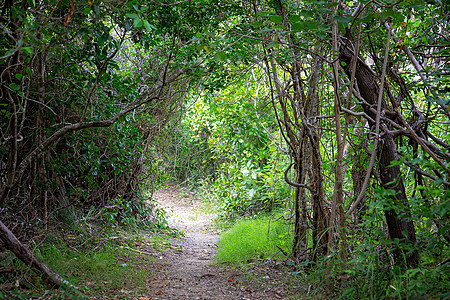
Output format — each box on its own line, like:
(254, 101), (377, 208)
(0, 0), (450, 299)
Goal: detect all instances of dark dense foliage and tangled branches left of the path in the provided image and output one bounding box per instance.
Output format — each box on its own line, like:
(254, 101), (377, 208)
(0, 1), (225, 232)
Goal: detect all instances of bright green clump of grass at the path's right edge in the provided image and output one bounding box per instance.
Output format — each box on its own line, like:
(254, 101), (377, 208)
(216, 217), (292, 265)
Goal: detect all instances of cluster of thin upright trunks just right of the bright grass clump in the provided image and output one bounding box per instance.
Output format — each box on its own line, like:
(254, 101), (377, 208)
(260, 38), (328, 260)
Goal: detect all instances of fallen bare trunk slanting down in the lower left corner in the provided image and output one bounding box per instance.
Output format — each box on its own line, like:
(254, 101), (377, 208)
(0, 221), (71, 287)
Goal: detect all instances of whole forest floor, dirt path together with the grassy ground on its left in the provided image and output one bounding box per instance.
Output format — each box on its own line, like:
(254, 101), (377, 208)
(0, 185), (306, 300)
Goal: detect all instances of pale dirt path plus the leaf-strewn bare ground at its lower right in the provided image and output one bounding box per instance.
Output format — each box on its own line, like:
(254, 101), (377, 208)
(146, 186), (298, 300)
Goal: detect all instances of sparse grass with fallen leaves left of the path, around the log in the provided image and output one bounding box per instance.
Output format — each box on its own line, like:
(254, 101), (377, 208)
(0, 235), (174, 299)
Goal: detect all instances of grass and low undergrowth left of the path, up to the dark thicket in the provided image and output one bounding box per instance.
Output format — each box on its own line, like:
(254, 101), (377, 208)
(0, 188), (181, 299)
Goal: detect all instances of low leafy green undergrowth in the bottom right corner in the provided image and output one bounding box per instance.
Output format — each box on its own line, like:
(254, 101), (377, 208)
(293, 247), (450, 300)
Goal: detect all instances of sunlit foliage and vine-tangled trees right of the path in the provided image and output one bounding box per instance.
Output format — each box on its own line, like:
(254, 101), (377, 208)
(180, 1), (450, 298)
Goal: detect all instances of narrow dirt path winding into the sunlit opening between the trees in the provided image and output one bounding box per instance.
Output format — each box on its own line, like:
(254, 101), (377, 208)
(151, 187), (284, 300)
